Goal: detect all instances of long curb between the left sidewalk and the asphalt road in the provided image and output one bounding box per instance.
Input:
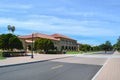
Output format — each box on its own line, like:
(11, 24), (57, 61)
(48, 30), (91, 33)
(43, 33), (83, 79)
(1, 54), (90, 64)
(0, 56), (72, 68)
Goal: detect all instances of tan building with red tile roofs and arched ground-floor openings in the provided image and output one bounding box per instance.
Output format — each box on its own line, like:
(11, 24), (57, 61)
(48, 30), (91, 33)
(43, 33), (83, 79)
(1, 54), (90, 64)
(19, 33), (79, 51)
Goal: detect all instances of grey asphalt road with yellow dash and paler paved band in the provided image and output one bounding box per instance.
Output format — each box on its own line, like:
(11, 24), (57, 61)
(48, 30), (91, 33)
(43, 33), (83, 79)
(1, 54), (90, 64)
(0, 57), (106, 80)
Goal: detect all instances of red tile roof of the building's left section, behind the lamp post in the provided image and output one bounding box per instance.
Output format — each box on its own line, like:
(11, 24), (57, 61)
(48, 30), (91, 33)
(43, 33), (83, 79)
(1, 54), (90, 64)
(19, 33), (59, 40)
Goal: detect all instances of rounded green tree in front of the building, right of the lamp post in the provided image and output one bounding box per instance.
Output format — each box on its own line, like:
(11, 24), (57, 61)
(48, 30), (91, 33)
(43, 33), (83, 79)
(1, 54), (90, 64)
(34, 38), (54, 53)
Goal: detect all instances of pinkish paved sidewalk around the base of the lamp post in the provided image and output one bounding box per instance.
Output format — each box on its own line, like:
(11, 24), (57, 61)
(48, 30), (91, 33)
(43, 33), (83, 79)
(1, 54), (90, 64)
(0, 54), (70, 67)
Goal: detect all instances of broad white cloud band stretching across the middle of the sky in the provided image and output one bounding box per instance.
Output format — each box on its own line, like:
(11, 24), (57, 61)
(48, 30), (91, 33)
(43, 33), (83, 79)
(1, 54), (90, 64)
(0, 15), (119, 37)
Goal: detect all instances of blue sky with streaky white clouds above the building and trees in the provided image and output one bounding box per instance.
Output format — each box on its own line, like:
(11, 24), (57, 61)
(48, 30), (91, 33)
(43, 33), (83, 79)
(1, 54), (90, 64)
(0, 0), (120, 45)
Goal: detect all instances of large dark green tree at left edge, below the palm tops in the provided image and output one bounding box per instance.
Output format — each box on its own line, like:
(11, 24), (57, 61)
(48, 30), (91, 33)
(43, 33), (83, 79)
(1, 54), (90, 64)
(0, 34), (23, 50)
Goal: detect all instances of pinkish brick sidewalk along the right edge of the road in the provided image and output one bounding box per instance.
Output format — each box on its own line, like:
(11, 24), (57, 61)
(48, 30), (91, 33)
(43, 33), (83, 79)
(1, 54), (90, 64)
(92, 52), (120, 80)
